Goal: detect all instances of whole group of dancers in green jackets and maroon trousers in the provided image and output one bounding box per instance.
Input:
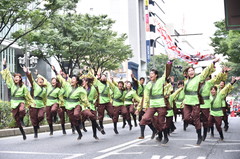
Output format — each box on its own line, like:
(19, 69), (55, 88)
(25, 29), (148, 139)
(1, 59), (240, 145)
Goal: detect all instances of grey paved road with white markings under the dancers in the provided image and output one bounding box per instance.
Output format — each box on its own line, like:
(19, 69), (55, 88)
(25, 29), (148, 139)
(0, 118), (240, 159)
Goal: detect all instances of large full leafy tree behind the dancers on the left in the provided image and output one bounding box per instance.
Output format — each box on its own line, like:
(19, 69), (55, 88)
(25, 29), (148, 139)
(16, 13), (132, 75)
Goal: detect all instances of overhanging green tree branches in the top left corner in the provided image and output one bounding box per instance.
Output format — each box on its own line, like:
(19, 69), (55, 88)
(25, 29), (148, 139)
(0, 0), (78, 53)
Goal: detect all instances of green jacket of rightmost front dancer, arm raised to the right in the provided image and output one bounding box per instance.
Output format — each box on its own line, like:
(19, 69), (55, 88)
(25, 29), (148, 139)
(210, 84), (233, 116)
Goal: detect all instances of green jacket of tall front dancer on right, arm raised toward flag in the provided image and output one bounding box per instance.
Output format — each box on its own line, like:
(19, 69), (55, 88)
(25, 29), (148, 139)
(183, 64), (215, 106)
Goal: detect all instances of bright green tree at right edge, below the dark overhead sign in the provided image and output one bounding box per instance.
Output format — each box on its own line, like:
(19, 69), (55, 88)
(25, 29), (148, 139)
(211, 20), (240, 63)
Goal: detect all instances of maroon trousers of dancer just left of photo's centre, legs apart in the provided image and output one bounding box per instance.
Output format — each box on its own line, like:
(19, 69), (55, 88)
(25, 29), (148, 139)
(97, 102), (113, 121)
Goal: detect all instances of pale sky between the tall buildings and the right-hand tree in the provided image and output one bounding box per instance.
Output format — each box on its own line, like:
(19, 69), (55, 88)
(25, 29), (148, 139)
(165, 0), (225, 52)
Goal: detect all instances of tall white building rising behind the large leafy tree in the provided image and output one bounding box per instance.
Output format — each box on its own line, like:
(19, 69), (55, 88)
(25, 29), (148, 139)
(77, 0), (169, 80)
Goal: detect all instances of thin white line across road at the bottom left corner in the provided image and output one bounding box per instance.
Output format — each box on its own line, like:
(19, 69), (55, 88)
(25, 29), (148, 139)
(0, 151), (84, 156)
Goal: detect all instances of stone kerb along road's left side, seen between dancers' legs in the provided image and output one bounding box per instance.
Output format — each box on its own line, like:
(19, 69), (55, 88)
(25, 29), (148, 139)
(0, 117), (114, 138)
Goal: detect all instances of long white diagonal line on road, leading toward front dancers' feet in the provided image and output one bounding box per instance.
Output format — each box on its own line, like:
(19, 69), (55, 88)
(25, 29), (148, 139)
(94, 136), (151, 159)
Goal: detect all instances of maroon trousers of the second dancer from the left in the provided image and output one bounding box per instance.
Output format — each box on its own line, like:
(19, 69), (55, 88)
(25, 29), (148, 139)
(29, 107), (45, 126)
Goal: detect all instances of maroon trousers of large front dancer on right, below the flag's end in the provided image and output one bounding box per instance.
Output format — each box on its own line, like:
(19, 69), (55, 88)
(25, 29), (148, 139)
(183, 104), (201, 130)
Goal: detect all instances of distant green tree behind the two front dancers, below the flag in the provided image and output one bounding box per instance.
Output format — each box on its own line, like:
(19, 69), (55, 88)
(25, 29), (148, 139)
(147, 54), (189, 81)
